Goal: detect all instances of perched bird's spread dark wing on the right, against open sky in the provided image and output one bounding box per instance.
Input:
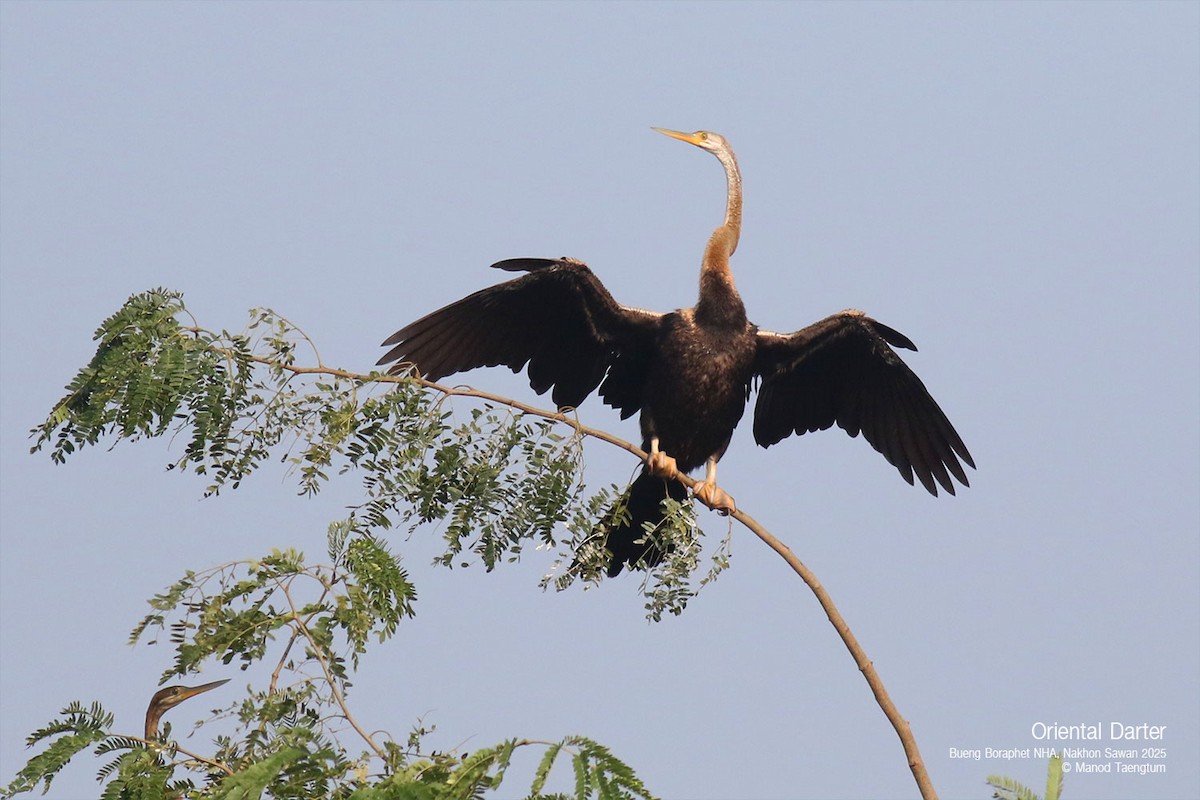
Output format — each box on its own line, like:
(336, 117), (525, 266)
(754, 311), (974, 495)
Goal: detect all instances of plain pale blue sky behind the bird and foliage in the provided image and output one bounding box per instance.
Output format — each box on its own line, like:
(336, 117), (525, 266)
(0, 0), (1200, 800)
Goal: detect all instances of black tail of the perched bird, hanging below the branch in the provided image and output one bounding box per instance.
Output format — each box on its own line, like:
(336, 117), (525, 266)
(600, 469), (689, 578)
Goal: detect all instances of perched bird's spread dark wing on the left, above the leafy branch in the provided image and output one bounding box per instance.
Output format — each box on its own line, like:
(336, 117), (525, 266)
(379, 258), (662, 416)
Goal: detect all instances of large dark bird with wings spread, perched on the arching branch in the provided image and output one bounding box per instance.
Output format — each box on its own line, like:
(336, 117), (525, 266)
(379, 128), (974, 576)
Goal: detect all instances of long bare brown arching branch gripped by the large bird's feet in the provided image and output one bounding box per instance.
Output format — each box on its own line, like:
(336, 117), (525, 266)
(206, 356), (937, 800)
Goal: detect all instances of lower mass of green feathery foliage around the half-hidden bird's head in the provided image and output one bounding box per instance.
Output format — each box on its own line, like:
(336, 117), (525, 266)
(4, 537), (653, 800)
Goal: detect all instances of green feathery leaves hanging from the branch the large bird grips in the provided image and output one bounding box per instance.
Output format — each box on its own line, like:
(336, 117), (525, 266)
(32, 289), (728, 609)
